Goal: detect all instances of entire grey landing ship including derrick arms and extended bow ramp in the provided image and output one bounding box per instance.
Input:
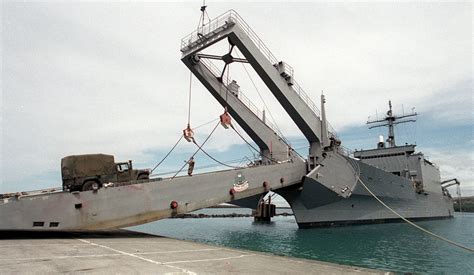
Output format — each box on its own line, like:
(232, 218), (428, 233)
(0, 9), (457, 231)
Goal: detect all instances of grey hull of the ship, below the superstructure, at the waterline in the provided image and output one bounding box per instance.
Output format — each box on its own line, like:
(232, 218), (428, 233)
(278, 161), (454, 228)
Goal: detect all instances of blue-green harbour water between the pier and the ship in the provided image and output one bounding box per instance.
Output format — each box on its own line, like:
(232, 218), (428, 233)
(131, 209), (474, 274)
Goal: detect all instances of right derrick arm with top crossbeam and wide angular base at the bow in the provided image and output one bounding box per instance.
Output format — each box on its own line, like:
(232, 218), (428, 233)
(181, 10), (358, 197)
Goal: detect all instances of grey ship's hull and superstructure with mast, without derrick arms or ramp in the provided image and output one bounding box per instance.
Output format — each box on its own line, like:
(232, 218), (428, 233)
(280, 101), (460, 228)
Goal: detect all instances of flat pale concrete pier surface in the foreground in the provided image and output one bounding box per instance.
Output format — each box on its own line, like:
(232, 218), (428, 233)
(0, 230), (385, 274)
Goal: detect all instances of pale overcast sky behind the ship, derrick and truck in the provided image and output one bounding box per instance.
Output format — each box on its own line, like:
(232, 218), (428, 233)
(0, 1), (474, 198)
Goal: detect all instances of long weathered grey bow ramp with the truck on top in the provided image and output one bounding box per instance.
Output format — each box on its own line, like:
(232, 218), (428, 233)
(0, 162), (306, 231)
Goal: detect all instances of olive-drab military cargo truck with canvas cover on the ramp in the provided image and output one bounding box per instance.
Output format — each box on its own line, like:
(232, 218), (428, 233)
(61, 154), (150, 192)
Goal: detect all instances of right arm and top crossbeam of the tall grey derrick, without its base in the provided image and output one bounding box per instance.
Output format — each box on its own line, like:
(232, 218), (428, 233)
(181, 10), (334, 163)
